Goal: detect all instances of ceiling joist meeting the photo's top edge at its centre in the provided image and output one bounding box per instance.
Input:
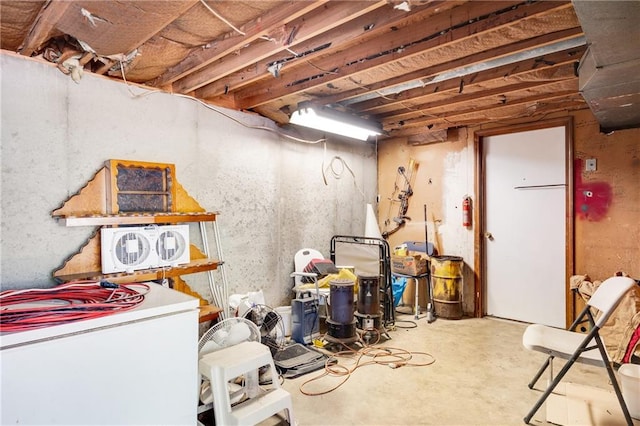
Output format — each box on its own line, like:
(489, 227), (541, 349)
(147, 0), (328, 87)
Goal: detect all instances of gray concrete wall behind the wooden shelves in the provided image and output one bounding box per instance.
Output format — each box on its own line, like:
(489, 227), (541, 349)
(0, 53), (377, 306)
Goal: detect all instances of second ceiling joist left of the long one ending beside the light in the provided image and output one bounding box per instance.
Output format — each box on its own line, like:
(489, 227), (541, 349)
(173, 0), (387, 93)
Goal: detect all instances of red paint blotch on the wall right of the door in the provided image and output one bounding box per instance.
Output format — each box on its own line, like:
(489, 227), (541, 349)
(573, 158), (613, 222)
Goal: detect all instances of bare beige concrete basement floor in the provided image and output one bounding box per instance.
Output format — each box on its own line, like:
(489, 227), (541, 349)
(265, 307), (640, 426)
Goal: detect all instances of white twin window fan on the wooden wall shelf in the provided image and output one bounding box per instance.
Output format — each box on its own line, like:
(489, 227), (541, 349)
(100, 225), (190, 274)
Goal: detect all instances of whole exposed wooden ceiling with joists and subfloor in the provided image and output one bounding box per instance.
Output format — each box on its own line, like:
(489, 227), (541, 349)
(0, 0), (586, 143)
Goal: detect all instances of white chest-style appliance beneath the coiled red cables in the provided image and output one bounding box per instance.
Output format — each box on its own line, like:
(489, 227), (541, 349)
(0, 283), (199, 425)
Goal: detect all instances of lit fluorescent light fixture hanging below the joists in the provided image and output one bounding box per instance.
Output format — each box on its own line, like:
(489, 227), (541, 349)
(289, 102), (382, 141)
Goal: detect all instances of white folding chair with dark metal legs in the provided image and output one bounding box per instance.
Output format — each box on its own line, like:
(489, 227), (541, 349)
(522, 277), (635, 426)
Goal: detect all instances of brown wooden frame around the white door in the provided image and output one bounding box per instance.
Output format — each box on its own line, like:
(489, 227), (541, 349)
(473, 116), (576, 327)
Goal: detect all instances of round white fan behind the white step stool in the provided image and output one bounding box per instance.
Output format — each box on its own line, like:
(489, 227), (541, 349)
(198, 317), (260, 413)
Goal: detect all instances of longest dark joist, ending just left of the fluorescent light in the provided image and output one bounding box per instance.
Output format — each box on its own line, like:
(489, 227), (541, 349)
(236, 2), (573, 109)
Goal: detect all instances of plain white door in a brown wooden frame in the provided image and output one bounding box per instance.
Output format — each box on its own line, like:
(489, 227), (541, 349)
(483, 127), (567, 328)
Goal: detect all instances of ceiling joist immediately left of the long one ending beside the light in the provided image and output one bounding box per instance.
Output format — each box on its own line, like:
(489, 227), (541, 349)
(196, 0), (456, 99)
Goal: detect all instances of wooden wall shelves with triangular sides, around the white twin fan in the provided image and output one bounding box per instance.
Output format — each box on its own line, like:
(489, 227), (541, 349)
(52, 160), (224, 322)
